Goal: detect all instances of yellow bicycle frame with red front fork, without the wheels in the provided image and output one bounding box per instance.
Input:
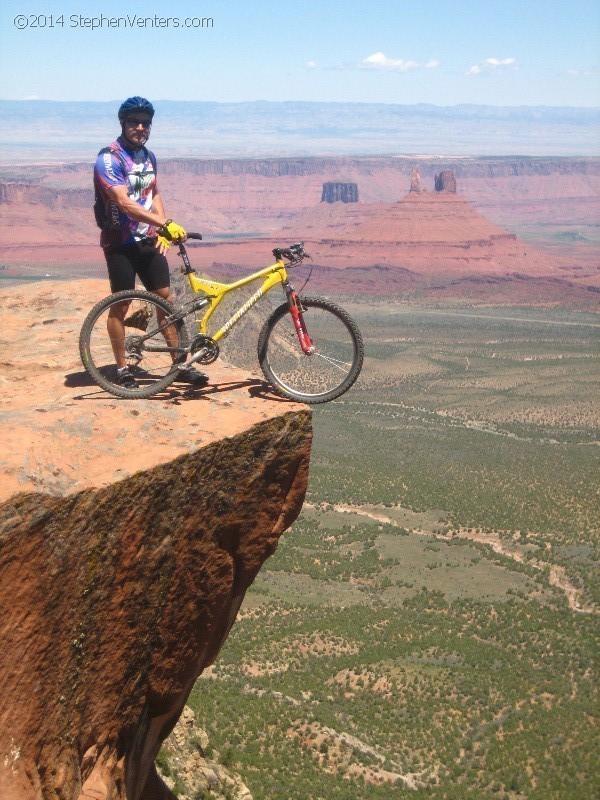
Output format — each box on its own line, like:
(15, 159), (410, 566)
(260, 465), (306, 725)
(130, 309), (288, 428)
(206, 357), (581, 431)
(179, 243), (314, 355)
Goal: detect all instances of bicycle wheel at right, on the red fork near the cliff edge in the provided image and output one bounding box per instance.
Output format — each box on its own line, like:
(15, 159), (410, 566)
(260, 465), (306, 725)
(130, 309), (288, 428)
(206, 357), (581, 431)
(258, 297), (364, 403)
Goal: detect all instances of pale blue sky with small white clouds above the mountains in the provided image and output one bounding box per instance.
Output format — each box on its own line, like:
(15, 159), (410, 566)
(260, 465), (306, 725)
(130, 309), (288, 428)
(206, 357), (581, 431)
(0, 0), (600, 107)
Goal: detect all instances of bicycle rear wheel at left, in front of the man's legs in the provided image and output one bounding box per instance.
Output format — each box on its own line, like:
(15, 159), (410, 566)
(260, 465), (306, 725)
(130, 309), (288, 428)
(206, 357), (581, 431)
(79, 290), (188, 398)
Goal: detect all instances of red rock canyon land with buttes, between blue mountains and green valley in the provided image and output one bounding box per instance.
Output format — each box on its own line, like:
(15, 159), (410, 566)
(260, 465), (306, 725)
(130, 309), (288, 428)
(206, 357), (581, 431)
(0, 157), (600, 305)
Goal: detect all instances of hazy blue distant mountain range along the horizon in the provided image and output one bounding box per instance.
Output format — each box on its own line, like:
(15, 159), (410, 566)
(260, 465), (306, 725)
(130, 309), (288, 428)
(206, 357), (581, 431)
(0, 100), (600, 164)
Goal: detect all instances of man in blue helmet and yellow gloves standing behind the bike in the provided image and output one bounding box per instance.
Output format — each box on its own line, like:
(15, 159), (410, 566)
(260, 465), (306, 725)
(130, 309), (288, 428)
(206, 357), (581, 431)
(94, 96), (207, 389)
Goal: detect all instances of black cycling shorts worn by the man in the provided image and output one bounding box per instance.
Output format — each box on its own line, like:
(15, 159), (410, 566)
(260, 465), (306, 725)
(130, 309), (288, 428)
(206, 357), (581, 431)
(104, 239), (171, 292)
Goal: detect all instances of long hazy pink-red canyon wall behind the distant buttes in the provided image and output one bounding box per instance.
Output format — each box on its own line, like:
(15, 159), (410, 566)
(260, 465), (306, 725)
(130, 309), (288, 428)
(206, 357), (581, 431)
(0, 153), (600, 274)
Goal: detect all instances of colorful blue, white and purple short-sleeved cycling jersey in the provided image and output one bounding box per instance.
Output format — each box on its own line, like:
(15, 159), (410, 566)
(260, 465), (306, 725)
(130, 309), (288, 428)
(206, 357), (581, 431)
(94, 137), (158, 247)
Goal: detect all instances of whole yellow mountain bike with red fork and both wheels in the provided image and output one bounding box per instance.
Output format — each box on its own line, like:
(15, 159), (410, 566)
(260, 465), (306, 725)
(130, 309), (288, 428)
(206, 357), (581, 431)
(79, 233), (364, 403)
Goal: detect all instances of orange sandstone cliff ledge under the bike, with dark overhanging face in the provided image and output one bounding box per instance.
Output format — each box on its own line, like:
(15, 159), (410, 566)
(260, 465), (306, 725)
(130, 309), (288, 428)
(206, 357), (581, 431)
(0, 281), (311, 800)
